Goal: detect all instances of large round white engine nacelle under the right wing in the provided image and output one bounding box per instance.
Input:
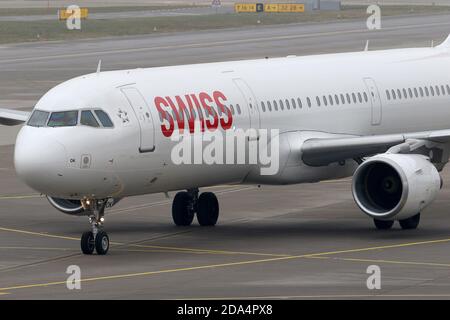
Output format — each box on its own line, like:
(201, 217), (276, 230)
(352, 153), (442, 220)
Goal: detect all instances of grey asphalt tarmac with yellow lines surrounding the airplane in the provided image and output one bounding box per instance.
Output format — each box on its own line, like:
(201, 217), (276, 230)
(0, 15), (450, 299)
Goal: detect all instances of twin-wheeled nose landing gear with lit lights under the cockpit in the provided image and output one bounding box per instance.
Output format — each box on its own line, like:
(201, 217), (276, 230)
(81, 200), (109, 255)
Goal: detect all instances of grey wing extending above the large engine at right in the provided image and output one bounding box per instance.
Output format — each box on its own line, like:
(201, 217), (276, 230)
(301, 130), (450, 167)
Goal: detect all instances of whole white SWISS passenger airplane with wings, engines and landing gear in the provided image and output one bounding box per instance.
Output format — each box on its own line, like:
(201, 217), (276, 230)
(0, 36), (450, 255)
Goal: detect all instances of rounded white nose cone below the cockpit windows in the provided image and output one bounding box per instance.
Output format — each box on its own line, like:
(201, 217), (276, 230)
(14, 126), (67, 195)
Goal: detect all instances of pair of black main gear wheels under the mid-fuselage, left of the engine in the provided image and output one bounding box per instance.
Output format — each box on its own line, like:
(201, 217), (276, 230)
(172, 189), (219, 226)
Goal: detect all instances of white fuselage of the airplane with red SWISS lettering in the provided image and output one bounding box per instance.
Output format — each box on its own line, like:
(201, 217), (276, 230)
(15, 48), (450, 199)
